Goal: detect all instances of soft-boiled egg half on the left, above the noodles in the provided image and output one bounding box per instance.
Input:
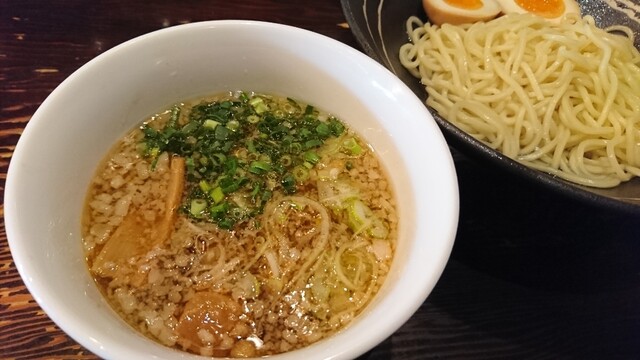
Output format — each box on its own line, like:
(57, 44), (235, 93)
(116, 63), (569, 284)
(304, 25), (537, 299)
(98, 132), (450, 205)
(422, 0), (502, 25)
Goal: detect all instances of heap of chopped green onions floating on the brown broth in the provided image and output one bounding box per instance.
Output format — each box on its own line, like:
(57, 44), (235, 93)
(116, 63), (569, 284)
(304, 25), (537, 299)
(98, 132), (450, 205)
(140, 92), (347, 229)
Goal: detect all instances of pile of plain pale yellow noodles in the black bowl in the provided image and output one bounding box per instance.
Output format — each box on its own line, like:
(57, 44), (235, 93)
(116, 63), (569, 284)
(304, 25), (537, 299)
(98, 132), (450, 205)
(400, 14), (640, 188)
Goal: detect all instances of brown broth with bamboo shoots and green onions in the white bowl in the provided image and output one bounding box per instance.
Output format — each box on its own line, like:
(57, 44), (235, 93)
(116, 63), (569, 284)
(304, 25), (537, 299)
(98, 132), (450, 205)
(82, 92), (397, 357)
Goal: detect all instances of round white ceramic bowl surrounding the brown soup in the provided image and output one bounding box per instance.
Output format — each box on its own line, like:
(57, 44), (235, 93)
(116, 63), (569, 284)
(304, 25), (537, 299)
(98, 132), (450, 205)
(5, 20), (458, 360)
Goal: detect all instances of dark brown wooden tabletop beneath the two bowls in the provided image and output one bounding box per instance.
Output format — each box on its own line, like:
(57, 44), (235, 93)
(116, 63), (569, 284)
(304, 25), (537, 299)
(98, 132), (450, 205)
(0, 0), (640, 359)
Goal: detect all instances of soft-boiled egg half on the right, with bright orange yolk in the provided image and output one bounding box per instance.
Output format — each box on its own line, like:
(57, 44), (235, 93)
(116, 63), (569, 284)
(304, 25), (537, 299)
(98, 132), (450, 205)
(497, 0), (580, 21)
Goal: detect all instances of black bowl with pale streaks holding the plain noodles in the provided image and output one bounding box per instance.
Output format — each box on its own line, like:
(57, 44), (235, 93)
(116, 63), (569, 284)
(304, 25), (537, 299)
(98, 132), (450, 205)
(341, 0), (640, 215)
